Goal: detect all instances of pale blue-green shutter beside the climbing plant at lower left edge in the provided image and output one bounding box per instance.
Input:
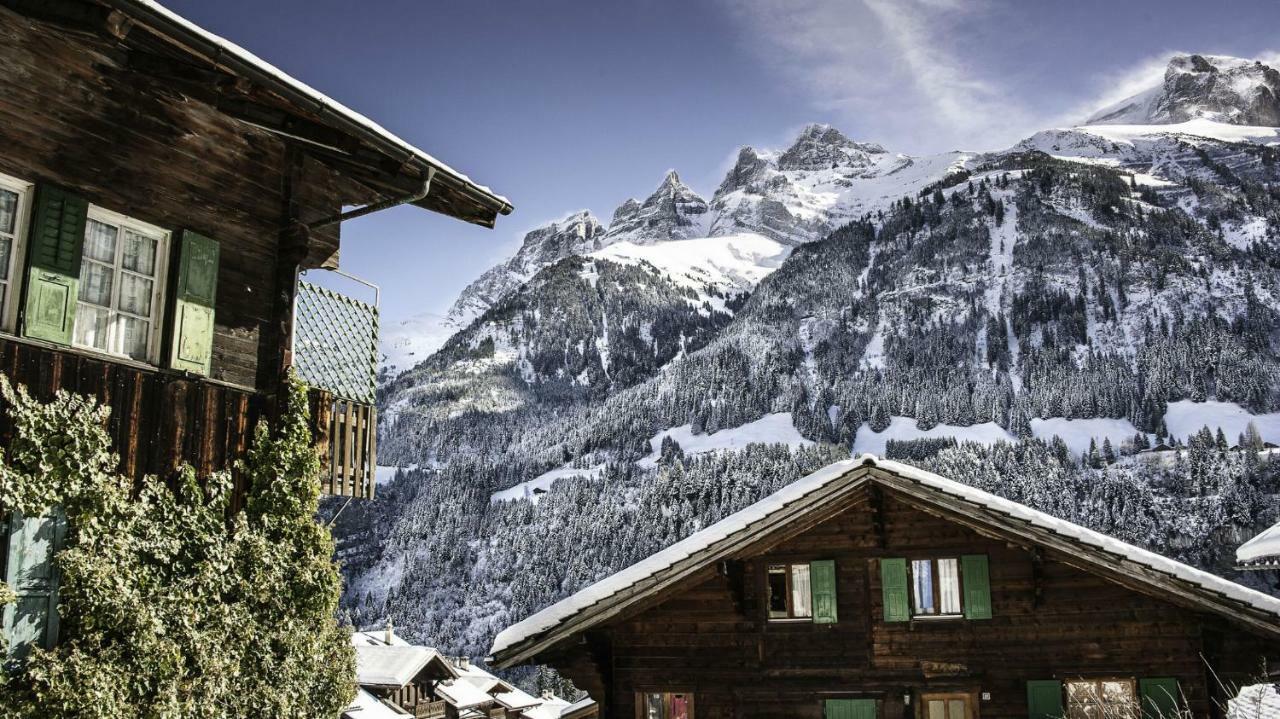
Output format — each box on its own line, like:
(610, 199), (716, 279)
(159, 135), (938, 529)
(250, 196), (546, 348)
(4, 510), (67, 659)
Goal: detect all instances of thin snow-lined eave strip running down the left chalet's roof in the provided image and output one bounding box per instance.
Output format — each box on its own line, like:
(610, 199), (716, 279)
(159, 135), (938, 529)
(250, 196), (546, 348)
(100, 0), (515, 215)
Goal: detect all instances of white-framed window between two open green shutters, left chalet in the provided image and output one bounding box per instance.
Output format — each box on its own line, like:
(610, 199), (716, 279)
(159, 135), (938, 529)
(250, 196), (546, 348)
(73, 206), (169, 362)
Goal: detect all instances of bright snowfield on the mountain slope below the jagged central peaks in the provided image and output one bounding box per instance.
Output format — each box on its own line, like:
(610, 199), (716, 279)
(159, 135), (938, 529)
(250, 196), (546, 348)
(589, 233), (791, 299)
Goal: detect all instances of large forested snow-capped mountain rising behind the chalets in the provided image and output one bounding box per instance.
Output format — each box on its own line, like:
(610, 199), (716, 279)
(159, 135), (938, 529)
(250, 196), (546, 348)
(339, 53), (1280, 670)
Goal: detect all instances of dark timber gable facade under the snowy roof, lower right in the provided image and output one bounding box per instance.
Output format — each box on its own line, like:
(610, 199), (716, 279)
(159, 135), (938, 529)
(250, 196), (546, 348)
(497, 458), (1280, 719)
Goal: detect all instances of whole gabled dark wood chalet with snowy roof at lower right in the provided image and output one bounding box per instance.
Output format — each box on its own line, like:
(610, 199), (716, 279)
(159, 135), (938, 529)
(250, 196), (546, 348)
(490, 457), (1280, 719)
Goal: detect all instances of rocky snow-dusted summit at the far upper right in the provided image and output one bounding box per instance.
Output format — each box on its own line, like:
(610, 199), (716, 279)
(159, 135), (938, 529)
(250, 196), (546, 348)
(1088, 55), (1280, 127)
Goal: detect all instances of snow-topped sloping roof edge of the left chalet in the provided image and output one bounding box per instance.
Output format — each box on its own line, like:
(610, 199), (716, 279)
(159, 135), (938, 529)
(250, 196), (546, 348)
(108, 0), (512, 221)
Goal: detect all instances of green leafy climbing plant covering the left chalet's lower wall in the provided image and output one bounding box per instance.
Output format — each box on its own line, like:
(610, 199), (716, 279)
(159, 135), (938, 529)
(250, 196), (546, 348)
(0, 377), (355, 719)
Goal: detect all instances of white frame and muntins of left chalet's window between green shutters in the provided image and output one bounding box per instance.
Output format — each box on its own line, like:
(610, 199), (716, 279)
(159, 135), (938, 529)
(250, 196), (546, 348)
(72, 203), (173, 366)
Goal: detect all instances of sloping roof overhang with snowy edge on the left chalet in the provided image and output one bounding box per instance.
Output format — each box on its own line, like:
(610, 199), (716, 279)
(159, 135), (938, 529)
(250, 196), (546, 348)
(96, 0), (513, 226)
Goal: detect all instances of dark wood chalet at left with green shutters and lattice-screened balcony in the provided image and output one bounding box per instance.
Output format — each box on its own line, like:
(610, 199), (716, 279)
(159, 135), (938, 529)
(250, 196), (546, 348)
(0, 0), (512, 647)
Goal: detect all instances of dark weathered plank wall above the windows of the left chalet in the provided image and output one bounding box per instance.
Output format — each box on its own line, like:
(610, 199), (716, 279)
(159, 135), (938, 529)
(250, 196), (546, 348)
(0, 8), (356, 391)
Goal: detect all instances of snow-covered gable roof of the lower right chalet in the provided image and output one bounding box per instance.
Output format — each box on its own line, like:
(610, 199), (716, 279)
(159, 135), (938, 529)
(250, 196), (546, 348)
(489, 454), (1280, 668)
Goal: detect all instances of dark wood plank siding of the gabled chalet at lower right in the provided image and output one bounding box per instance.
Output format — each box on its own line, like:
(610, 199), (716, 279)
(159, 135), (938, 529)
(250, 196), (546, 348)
(581, 490), (1280, 719)
